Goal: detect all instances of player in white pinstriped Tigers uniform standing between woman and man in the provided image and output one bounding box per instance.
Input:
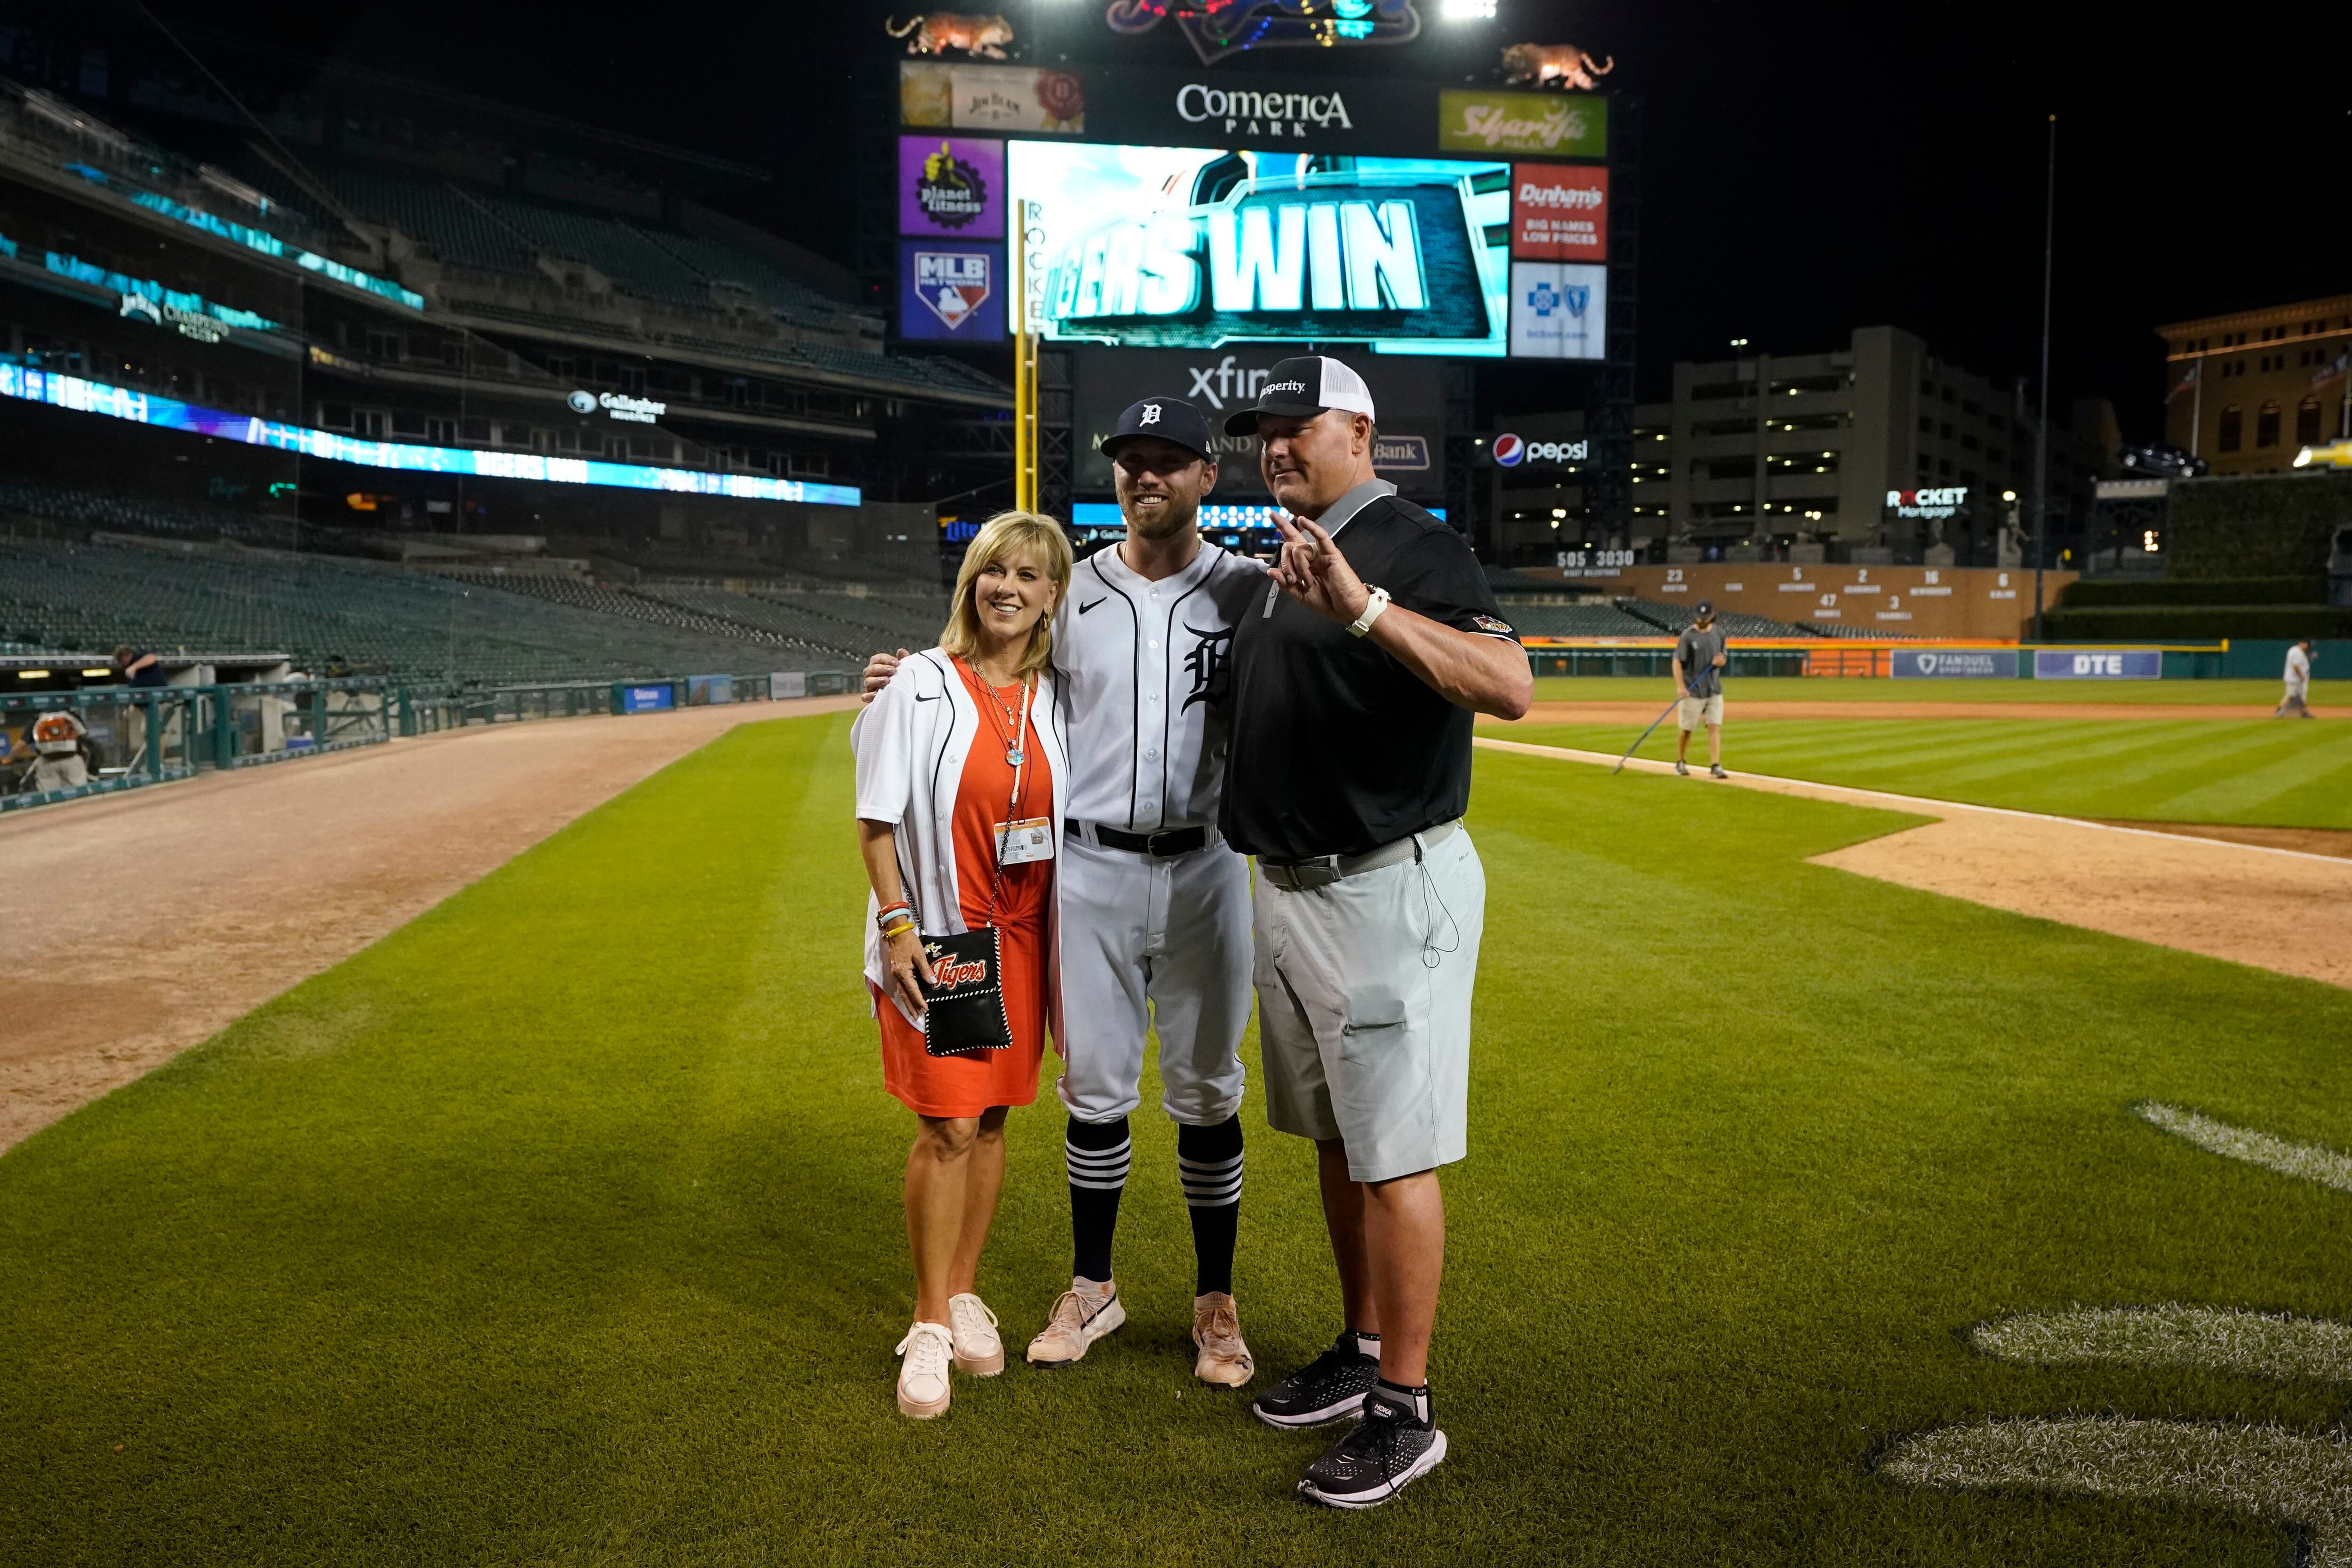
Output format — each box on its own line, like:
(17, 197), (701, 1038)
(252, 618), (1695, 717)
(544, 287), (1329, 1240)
(866, 397), (1265, 1387)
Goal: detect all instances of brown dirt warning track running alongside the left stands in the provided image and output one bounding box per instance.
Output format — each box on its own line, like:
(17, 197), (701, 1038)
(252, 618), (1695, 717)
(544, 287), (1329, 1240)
(0, 698), (856, 1150)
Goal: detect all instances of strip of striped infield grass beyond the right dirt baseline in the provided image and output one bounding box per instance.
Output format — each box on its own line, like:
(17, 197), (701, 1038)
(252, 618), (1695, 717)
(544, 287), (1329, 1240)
(1479, 715), (2352, 828)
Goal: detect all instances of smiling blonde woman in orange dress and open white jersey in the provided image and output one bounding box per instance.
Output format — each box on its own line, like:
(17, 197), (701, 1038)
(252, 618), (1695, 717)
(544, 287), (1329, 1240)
(849, 512), (1070, 1420)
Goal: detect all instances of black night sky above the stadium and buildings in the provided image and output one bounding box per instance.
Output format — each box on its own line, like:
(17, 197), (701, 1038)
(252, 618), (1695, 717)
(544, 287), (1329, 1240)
(103, 0), (2352, 437)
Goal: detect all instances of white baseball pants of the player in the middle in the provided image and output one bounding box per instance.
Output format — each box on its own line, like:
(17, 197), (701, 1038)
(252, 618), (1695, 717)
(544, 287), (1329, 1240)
(1058, 832), (1251, 1126)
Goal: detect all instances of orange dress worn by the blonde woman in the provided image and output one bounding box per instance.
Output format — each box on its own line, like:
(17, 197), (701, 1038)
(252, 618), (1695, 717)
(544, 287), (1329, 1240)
(868, 661), (1054, 1117)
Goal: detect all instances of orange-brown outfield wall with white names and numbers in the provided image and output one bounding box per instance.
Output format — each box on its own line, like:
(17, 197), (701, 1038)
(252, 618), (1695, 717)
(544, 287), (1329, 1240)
(1519, 562), (2079, 642)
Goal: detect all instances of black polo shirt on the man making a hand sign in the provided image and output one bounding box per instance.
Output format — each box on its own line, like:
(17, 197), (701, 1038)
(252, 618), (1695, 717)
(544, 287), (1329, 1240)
(1218, 491), (1517, 858)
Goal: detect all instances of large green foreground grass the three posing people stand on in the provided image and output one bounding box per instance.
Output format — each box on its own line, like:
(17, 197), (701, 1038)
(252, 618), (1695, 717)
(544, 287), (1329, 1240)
(0, 715), (2352, 1568)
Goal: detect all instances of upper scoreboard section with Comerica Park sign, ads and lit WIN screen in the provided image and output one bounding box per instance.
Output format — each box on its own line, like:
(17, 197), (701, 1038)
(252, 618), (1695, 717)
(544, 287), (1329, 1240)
(898, 61), (1609, 360)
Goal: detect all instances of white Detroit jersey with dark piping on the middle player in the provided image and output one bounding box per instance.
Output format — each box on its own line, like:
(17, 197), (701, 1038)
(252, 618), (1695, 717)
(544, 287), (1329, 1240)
(1054, 543), (1265, 832)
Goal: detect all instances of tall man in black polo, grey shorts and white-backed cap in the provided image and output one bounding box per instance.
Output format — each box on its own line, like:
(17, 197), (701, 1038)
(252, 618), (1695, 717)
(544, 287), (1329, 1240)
(1218, 355), (1534, 1507)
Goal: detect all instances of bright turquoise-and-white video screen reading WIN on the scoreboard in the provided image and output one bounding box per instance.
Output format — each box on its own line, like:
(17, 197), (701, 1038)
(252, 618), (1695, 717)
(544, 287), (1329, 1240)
(1007, 141), (1505, 358)
